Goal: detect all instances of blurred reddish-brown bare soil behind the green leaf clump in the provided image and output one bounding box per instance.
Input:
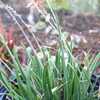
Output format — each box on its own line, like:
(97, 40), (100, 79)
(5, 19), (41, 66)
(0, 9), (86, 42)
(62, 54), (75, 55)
(15, 12), (100, 52)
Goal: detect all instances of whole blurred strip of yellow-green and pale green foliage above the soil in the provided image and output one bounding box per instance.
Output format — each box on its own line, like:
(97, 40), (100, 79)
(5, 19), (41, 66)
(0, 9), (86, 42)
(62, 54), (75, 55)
(49, 0), (99, 13)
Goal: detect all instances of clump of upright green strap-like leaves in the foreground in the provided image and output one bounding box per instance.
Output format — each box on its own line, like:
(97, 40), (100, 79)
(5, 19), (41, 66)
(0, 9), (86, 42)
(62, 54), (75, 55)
(0, 40), (98, 100)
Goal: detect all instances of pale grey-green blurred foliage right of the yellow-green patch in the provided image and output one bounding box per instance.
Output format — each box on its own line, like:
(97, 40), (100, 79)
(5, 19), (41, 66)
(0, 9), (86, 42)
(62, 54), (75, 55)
(70, 0), (98, 13)
